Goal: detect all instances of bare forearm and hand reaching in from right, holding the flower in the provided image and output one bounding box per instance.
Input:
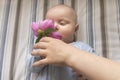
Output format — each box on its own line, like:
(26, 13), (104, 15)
(32, 37), (120, 80)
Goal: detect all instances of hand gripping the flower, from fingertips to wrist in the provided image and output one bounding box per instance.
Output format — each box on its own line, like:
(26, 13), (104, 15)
(32, 37), (74, 66)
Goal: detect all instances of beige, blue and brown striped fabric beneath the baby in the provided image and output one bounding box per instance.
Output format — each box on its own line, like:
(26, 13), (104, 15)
(0, 0), (120, 80)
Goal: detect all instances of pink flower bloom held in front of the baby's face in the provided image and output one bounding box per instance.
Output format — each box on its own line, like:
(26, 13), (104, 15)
(31, 19), (62, 41)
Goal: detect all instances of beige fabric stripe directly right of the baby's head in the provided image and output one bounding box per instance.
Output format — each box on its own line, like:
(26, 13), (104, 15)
(75, 0), (87, 43)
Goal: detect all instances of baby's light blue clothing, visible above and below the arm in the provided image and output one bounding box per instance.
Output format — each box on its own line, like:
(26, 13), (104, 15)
(26, 41), (96, 80)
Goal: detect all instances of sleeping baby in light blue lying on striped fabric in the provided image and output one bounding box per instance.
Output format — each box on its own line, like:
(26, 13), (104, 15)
(27, 4), (97, 80)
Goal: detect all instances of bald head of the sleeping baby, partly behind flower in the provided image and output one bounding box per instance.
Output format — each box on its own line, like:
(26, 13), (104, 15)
(46, 5), (78, 43)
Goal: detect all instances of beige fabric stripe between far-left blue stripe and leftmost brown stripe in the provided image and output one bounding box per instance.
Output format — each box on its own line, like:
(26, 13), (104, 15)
(2, 1), (17, 80)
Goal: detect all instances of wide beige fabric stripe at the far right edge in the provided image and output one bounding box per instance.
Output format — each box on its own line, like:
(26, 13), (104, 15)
(105, 0), (120, 60)
